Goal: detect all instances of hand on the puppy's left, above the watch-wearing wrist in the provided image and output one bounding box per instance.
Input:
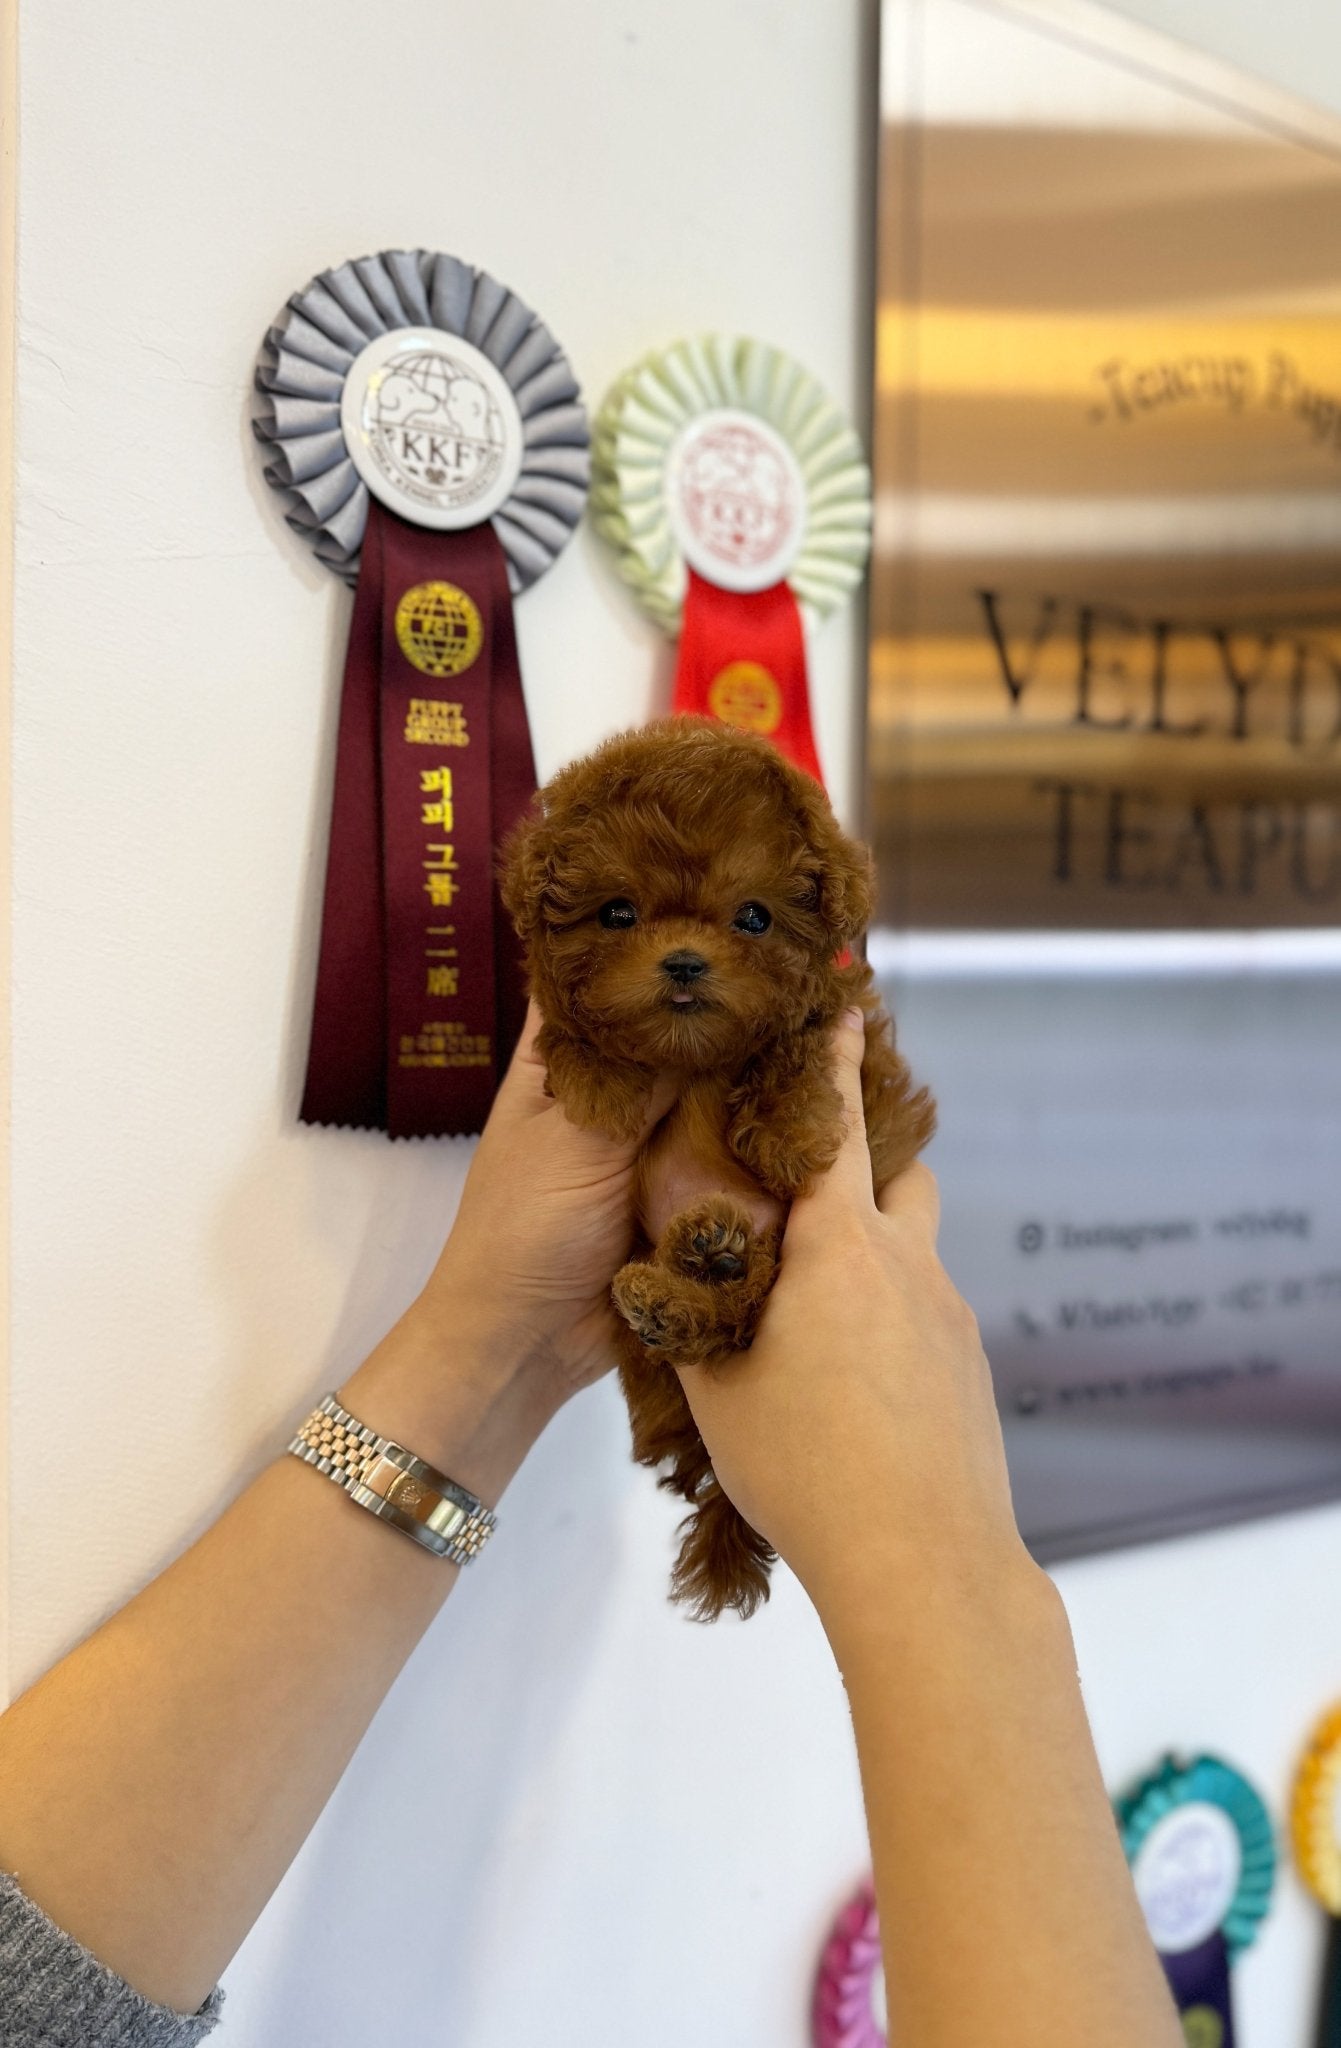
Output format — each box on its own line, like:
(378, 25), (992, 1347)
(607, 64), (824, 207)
(416, 1004), (674, 1401)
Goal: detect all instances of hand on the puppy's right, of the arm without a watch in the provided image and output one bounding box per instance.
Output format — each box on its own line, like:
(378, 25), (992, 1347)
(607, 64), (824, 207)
(680, 1020), (1032, 1634)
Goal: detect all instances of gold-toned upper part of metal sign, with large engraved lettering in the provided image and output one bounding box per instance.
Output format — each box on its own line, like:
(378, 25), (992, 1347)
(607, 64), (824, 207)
(870, 0), (1341, 930)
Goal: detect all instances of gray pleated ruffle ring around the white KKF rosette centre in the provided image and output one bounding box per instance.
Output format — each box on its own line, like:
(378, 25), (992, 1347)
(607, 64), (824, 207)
(252, 250), (590, 592)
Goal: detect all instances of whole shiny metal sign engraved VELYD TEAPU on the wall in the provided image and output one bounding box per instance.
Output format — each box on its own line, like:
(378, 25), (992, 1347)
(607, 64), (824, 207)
(870, 0), (1341, 1559)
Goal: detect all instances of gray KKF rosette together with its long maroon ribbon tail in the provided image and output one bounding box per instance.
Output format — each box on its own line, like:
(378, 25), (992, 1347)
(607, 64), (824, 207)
(254, 250), (590, 1137)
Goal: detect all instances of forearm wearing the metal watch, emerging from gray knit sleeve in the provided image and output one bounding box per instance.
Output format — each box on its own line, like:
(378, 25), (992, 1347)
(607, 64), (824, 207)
(0, 1311), (557, 2011)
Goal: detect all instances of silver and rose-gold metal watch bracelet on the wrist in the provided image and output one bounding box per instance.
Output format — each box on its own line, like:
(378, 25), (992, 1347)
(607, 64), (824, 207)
(289, 1393), (498, 1565)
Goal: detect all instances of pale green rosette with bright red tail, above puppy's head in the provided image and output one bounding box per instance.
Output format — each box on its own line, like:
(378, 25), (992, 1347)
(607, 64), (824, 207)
(592, 334), (870, 780)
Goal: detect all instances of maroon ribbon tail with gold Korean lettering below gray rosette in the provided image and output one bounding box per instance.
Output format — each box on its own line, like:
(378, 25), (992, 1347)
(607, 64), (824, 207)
(299, 500), (536, 1137)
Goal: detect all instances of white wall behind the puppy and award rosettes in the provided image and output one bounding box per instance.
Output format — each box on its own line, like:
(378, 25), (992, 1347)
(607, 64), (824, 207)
(8, 0), (1341, 2048)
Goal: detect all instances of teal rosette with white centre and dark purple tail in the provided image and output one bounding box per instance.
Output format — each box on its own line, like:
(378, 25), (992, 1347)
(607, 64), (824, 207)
(1118, 1757), (1275, 2048)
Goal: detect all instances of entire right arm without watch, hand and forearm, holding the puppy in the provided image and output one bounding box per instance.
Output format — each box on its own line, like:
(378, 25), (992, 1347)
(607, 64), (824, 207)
(680, 1020), (1181, 2048)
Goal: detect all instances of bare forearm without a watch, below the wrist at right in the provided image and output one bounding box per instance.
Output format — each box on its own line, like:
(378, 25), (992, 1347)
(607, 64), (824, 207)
(825, 1552), (1181, 2048)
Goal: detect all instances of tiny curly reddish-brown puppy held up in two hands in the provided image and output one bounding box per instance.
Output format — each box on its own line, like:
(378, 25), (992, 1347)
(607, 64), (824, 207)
(504, 717), (936, 1620)
